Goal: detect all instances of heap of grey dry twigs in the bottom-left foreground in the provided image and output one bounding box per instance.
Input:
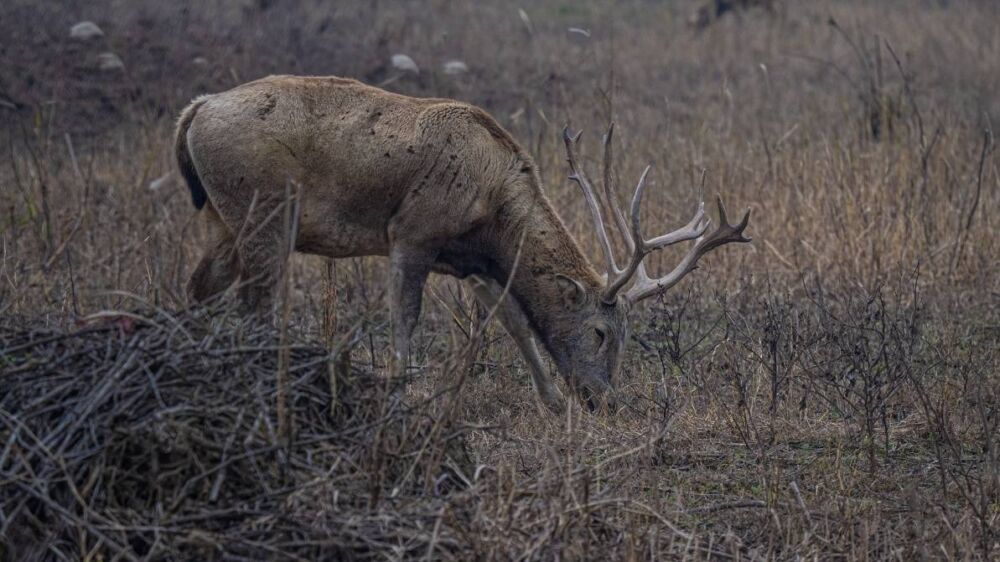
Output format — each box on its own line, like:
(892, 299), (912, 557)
(0, 312), (476, 560)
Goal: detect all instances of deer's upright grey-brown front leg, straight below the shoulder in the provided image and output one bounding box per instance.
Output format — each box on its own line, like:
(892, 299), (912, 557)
(388, 244), (437, 377)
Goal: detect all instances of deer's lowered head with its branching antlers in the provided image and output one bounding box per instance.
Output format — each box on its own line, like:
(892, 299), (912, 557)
(553, 125), (750, 410)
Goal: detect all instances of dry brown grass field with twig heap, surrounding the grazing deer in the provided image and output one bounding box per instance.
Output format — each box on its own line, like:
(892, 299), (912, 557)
(0, 0), (1000, 560)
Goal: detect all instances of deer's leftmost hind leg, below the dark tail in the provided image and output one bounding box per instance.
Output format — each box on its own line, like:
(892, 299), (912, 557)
(187, 203), (240, 303)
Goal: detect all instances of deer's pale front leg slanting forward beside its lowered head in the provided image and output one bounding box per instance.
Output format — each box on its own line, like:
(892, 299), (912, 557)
(469, 275), (565, 415)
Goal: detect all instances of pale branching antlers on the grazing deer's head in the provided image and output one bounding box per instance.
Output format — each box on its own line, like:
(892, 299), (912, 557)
(563, 125), (750, 303)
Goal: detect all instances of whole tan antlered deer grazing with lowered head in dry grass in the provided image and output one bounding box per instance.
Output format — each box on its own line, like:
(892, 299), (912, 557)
(175, 76), (749, 412)
